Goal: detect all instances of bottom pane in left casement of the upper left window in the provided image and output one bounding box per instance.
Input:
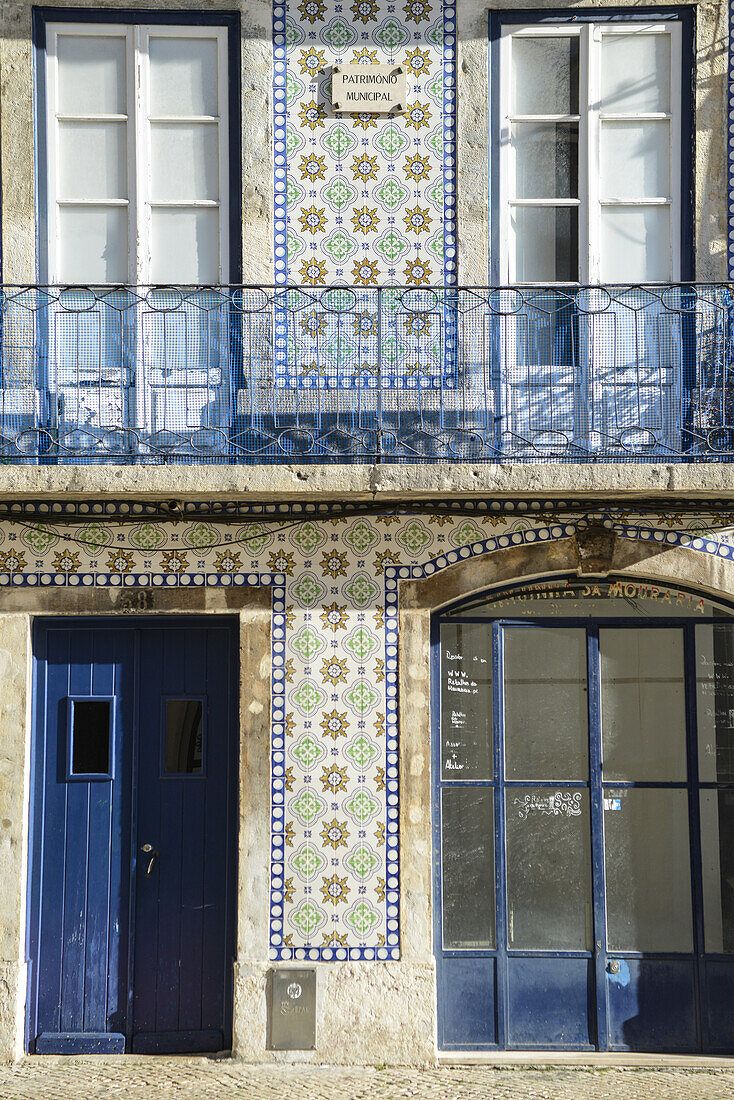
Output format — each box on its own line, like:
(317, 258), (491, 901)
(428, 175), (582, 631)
(57, 206), (128, 283)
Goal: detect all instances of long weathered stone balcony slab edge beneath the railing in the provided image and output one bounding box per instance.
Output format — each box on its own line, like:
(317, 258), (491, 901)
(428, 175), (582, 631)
(0, 462), (734, 503)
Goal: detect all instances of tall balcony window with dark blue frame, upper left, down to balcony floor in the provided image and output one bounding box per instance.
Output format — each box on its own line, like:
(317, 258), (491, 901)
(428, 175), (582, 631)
(24, 8), (242, 463)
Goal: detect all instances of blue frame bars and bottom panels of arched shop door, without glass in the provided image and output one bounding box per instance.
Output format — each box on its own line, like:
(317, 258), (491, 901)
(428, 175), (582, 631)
(431, 597), (734, 1053)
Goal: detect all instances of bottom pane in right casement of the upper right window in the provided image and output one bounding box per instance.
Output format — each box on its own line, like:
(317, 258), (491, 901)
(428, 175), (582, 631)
(601, 206), (670, 283)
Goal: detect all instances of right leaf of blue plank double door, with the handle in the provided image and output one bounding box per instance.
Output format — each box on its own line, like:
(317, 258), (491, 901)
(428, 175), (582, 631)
(132, 626), (235, 1053)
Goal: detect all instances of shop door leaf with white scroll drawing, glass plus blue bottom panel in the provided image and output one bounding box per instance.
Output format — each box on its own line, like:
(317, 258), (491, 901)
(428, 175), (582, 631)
(502, 626), (596, 1048)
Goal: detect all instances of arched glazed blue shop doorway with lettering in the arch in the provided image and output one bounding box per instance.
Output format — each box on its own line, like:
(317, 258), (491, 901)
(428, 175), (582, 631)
(432, 576), (734, 1052)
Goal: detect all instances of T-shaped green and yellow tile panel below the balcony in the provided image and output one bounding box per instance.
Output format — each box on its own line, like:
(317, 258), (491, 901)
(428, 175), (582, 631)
(0, 502), (734, 960)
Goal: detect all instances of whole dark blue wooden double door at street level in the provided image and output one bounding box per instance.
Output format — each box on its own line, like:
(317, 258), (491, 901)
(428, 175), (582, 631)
(28, 620), (237, 1053)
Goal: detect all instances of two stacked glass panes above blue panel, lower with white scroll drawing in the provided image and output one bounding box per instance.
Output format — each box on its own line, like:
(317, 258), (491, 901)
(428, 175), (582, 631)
(503, 627), (592, 950)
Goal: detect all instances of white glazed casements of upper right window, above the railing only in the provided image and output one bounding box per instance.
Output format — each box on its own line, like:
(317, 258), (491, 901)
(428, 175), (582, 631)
(499, 21), (681, 284)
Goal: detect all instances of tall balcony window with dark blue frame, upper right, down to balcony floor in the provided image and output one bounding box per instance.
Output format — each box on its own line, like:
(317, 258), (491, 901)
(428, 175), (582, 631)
(489, 8), (699, 461)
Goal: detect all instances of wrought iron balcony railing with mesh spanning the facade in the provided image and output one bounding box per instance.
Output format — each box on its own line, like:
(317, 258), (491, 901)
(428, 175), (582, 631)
(0, 284), (734, 464)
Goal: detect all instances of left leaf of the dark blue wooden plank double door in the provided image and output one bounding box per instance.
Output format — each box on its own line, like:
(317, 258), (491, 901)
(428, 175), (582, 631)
(28, 626), (135, 1054)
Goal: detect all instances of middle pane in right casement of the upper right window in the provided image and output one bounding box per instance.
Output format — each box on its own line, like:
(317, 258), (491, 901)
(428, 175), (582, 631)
(601, 121), (670, 199)
